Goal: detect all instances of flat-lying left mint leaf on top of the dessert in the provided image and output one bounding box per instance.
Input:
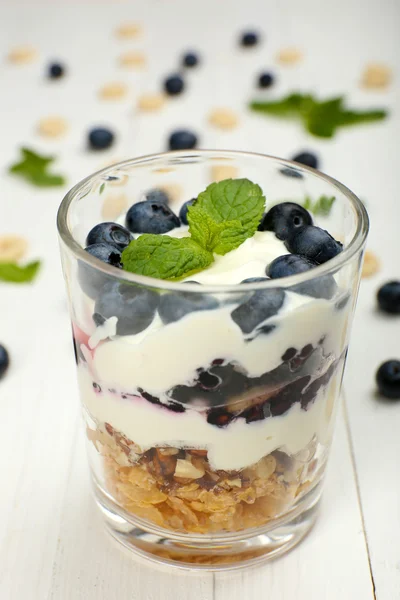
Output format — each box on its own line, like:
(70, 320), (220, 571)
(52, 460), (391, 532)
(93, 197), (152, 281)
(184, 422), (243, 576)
(122, 233), (214, 280)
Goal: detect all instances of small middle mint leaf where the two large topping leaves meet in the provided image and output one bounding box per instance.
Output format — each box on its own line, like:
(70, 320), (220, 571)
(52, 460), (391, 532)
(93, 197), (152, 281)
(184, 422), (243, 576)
(188, 204), (247, 255)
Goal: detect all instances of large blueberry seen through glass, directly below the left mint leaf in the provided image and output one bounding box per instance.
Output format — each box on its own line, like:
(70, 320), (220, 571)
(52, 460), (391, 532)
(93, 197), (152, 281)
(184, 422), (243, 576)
(94, 281), (159, 335)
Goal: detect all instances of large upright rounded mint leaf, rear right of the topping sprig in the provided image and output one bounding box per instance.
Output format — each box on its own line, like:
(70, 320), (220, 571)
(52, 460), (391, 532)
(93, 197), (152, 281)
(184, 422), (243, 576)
(195, 179), (265, 237)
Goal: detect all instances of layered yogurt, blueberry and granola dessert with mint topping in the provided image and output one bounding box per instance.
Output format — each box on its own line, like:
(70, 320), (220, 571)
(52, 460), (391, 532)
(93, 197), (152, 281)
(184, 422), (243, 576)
(73, 180), (350, 534)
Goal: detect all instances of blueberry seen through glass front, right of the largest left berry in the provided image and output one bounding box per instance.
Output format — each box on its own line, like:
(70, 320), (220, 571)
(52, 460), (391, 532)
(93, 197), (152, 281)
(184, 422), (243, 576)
(158, 292), (219, 325)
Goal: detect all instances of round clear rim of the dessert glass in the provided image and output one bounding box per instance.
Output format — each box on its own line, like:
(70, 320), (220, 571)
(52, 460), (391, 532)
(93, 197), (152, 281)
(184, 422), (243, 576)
(57, 149), (369, 293)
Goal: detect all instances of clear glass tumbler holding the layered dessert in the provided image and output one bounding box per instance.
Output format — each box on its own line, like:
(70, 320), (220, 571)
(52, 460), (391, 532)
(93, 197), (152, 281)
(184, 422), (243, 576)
(58, 151), (368, 569)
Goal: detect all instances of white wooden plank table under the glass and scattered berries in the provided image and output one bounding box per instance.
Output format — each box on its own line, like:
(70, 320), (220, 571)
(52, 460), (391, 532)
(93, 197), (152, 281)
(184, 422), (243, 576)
(0, 0), (400, 600)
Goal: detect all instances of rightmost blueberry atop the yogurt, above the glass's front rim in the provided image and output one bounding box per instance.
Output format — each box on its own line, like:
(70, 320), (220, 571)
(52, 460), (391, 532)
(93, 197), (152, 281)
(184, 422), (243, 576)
(285, 225), (343, 265)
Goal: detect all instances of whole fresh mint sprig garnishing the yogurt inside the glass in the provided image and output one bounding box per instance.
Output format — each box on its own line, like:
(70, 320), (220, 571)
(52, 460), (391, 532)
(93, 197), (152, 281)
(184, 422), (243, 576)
(122, 179), (265, 280)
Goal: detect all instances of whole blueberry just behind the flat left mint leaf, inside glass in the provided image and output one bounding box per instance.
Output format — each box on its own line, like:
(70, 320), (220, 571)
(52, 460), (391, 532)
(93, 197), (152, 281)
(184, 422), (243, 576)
(126, 200), (181, 233)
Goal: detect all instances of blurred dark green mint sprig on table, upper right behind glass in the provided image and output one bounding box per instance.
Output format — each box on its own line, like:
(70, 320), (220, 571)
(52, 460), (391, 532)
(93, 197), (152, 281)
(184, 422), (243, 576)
(249, 93), (387, 138)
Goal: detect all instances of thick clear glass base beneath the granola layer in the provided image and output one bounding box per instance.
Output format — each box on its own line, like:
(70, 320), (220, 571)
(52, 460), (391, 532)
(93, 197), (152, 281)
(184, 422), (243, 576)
(94, 482), (322, 571)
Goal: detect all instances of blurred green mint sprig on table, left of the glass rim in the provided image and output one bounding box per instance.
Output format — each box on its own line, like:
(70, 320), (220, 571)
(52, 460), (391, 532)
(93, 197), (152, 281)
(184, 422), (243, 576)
(9, 148), (65, 187)
